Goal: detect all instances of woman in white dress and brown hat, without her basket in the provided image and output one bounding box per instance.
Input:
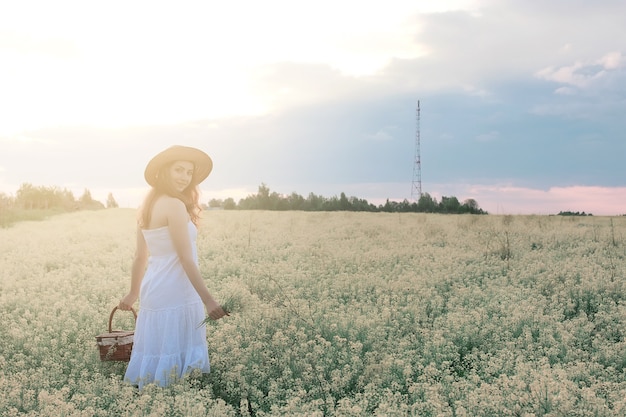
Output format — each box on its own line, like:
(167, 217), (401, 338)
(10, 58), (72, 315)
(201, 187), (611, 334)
(118, 146), (228, 388)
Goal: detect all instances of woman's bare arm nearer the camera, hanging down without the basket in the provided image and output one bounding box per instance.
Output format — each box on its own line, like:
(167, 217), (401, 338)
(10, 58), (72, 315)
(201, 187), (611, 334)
(166, 198), (227, 320)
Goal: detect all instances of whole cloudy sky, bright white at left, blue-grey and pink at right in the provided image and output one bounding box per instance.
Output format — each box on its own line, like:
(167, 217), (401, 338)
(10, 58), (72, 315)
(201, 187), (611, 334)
(0, 0), (626, 215)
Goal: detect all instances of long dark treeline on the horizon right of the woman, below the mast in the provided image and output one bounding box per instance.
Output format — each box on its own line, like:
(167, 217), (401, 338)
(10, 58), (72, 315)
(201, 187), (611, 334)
(209, 184), (488, 214)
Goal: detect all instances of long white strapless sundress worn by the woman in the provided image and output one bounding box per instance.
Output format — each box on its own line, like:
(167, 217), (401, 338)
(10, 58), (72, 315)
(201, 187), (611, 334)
(124, 221), (210, 389)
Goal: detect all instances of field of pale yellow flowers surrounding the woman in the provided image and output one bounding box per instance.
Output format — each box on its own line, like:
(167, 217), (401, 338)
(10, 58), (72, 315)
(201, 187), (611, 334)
(0, 209), (626, 417)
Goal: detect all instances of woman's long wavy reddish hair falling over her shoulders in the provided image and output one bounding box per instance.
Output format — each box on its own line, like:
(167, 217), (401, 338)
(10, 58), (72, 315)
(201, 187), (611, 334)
(138, 162), (202, 229)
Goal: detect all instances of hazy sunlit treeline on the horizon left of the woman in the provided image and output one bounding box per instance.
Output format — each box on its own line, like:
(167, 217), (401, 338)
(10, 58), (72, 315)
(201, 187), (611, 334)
(0, 183), (118, 211)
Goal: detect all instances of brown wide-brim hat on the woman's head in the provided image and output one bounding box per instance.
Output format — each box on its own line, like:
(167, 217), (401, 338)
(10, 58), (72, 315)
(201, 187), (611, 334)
(143, 145), (213, 187)
